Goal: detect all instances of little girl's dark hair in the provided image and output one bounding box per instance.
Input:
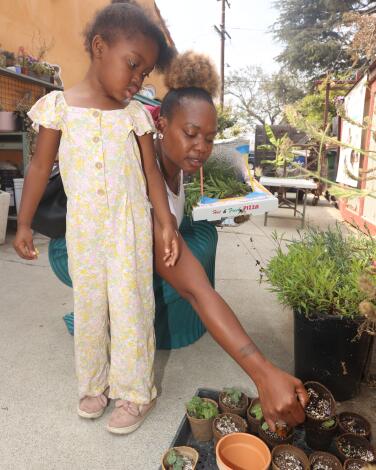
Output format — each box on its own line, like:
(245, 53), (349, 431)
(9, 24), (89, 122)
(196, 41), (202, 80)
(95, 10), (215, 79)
(84, 0), (174, 71)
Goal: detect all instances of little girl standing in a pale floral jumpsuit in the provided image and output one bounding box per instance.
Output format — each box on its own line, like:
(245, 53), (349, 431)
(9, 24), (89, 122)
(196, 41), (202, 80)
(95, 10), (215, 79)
(14, 3), (178, 434)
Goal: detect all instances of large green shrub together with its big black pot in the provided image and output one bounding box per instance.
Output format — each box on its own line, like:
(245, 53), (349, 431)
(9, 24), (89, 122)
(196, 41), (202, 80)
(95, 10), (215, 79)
(265, 224), (376, 401)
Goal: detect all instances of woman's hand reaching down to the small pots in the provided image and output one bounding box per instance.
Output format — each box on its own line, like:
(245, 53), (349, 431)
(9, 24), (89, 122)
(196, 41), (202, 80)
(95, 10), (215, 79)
(256, 363), (308, 431)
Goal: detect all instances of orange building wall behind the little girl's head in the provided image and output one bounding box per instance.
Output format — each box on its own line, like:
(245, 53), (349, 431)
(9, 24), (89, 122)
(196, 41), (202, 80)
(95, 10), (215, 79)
(0, 0), (165, 98)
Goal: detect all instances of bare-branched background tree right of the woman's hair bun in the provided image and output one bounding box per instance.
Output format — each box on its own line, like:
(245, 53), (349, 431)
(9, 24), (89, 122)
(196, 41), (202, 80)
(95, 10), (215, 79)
(225, 65), (304, 125)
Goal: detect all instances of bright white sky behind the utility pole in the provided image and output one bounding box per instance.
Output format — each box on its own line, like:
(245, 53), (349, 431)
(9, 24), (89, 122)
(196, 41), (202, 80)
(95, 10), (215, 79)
(156, 0), (281, 73)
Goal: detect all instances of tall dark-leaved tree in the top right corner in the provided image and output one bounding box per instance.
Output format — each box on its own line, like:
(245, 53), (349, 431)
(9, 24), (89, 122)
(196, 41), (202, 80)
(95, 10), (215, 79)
(272, 0), (375, 79)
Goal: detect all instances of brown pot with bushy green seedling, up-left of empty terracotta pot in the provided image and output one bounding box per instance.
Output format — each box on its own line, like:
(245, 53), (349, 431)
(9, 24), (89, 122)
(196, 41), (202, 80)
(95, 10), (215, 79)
(186, 397), (218, 442)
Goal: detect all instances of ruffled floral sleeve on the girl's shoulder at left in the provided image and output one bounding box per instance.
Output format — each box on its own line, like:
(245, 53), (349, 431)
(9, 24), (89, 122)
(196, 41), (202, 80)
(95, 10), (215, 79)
(27, 91), (63, 132)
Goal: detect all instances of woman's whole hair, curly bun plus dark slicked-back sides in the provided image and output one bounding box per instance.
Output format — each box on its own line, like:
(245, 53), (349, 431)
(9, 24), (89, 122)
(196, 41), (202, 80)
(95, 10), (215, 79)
(160, 51), (219, 119)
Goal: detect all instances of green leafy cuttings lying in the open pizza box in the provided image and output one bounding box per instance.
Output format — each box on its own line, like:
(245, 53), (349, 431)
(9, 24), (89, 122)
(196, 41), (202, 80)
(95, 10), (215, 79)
(185, 160), (251, 215)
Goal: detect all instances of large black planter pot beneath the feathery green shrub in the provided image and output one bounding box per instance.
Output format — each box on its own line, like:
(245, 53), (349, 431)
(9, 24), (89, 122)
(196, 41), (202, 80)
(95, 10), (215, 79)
(294, 312), (372, 401)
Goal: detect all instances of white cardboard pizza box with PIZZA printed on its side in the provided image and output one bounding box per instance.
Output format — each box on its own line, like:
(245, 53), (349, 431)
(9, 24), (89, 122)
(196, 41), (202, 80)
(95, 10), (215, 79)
(192, 181), (278, 221)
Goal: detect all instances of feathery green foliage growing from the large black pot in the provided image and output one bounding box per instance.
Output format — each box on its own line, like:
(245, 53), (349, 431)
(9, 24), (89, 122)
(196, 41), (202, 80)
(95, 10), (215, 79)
(265, 224), (376, 318)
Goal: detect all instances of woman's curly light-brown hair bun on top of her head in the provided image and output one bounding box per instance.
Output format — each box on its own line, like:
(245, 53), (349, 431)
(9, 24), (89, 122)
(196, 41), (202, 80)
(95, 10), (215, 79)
(165, 51), (219, 97)
